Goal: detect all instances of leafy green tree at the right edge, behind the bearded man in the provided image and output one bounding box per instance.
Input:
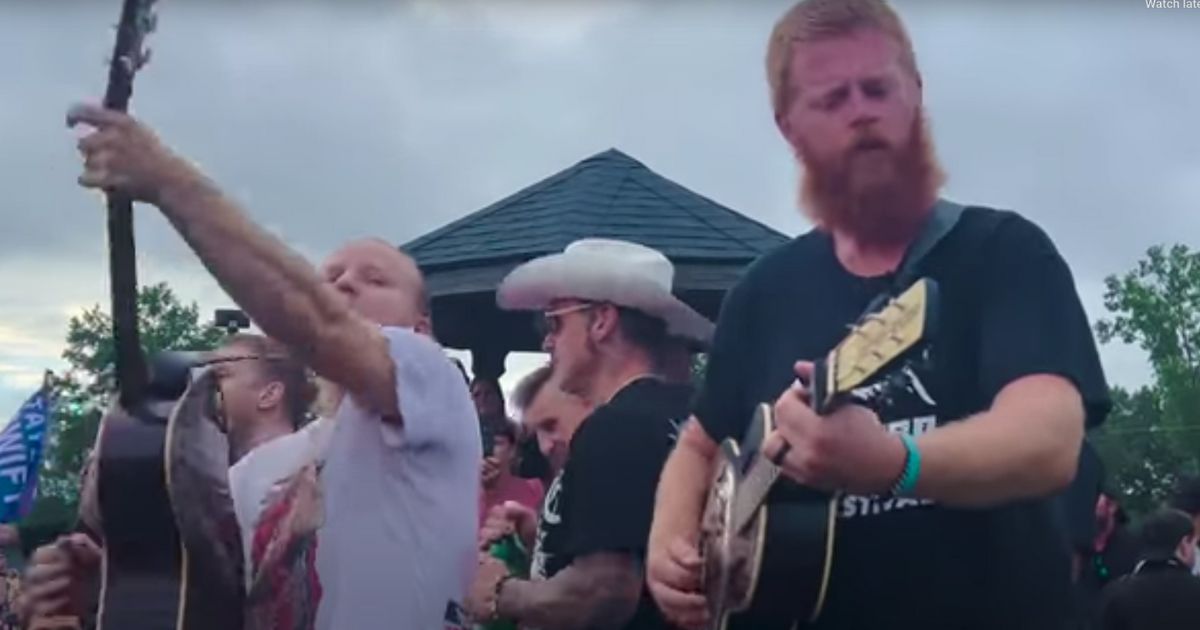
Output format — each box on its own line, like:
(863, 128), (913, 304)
(1096, 245), (1200, 511)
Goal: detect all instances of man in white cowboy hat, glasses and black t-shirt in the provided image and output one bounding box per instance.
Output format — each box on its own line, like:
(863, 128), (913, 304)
(467, 239), (713, 630)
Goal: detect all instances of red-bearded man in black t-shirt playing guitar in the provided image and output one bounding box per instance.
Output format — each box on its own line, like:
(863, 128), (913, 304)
(647, 0), (1109, 630)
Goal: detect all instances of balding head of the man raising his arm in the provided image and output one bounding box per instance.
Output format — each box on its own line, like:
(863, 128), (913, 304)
(320, 239), (430, 334)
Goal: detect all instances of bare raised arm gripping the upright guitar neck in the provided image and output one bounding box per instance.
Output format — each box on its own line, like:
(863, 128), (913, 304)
(67, 106), (398, 416)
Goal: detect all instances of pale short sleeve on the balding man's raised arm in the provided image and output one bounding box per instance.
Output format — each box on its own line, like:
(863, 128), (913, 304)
(383, 328), (478, 446)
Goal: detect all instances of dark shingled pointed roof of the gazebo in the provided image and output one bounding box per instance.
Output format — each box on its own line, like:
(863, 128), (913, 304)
(402, 149), (787, 272)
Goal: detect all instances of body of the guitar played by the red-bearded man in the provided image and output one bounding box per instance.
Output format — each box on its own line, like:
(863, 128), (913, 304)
(701, 404), (836, 630)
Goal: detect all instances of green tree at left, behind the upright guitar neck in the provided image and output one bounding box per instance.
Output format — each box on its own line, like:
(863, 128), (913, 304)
(30, 283), (224, 508)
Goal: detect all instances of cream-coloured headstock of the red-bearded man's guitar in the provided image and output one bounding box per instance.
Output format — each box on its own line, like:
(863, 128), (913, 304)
(811, 278), (937, 413)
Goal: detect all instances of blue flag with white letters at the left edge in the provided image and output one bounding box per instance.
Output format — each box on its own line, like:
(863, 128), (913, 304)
(0, 386), (52, 523)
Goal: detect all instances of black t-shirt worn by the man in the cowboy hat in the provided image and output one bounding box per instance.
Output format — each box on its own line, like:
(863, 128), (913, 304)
(530, 378), (691, 630)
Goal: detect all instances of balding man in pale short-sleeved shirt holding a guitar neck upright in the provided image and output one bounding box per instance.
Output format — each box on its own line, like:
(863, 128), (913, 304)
(67, 100), (482, 630)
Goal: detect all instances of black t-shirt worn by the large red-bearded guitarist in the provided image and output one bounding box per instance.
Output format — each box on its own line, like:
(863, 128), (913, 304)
(696, 208), (1109, 630)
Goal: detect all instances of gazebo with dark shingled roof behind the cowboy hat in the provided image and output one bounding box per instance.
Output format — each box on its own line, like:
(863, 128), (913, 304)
(401, 149), (788, 379)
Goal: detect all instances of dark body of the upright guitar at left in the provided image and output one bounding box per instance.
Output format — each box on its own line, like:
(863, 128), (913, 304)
(96, 360), (245, 630)
